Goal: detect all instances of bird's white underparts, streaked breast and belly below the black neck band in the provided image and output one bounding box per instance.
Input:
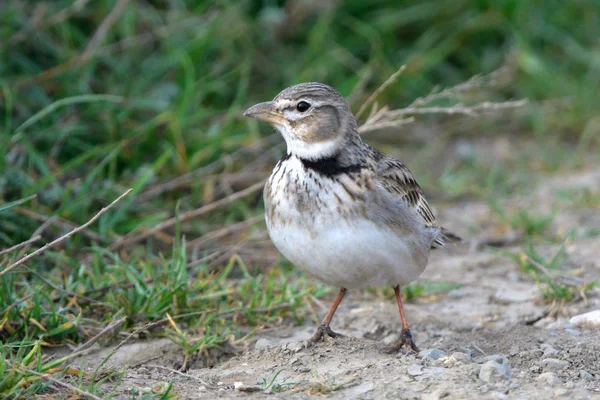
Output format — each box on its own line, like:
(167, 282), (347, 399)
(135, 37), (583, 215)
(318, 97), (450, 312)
(265, 155), (428, 289)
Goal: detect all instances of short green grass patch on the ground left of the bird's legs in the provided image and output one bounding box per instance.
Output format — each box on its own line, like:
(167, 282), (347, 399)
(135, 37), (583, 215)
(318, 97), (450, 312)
(0, 234), (326, 397)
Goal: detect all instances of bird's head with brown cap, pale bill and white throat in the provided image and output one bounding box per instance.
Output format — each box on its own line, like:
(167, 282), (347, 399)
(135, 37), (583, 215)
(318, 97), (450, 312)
(244, 82), (358, 160)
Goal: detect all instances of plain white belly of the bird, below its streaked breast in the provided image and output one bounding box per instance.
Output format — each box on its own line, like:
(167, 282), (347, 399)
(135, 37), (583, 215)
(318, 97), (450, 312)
(267, 218), (427, 289)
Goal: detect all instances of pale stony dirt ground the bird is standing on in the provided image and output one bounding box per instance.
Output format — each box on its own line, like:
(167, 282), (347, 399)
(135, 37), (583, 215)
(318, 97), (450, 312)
(77, 148), (600, 399)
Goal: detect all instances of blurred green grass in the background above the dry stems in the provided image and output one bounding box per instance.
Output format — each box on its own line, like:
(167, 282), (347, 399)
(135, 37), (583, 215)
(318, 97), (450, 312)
(0, 0), (600, 222)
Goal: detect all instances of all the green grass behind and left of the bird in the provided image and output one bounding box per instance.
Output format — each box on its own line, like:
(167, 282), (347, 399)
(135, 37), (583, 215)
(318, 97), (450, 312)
(0, 0), (600, 398)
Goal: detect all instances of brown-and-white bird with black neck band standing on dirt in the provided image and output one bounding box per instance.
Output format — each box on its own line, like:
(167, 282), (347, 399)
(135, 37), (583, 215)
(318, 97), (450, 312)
(244, 82), (458, 352)
